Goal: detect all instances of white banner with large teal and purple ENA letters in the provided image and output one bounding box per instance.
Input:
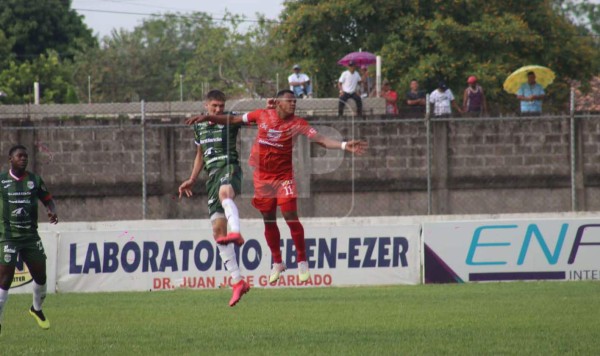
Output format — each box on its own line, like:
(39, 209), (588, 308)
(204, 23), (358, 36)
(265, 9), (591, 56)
(423, 219), (600, 283)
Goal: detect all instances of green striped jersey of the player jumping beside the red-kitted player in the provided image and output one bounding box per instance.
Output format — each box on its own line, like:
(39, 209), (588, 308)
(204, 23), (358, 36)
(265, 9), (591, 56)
(193, 113), (241, 172)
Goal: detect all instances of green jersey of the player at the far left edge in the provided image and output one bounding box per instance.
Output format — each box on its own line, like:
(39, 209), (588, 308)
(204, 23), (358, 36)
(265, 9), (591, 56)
(0, 172), (52, 241)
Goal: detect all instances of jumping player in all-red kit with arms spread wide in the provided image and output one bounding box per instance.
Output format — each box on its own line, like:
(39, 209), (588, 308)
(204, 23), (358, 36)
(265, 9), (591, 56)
(186, 90), (367, 283)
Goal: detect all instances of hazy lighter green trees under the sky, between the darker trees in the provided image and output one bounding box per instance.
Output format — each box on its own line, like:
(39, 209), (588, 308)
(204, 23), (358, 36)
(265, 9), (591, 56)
(75, 12), (284, 101)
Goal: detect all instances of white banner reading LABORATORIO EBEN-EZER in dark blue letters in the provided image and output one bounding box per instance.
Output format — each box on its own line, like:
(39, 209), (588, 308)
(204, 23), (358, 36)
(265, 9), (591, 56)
(57, 225), (421, 292)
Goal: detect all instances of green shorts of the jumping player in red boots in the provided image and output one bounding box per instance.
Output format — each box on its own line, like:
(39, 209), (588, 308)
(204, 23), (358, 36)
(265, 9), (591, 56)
(206, 164), (242, 218)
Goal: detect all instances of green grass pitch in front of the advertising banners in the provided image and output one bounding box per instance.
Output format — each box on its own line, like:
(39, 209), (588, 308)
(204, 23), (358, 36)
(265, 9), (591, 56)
(0, 282), (600, 356)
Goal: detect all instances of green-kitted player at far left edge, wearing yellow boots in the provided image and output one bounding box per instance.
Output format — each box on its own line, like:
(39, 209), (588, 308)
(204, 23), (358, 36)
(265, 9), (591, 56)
(0, 145), (58, 329)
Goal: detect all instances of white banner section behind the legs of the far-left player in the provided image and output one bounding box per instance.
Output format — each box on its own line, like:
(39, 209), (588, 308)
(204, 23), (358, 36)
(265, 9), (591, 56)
(10, 231), (58, 294)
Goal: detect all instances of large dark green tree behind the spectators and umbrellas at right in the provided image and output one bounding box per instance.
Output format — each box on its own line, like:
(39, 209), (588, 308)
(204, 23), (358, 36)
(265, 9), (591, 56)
(277, 0), (599, 111)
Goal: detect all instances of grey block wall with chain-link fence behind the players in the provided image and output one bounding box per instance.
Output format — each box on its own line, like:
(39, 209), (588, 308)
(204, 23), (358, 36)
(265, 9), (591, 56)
(0, 94), (600, 221)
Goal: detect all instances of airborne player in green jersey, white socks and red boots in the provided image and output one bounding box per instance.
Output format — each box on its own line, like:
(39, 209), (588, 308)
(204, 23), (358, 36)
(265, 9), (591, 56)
(179, 90), (250, 306)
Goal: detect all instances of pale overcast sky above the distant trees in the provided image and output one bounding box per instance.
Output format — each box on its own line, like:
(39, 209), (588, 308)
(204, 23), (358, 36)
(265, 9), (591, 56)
(71, 0), (283, 37)
